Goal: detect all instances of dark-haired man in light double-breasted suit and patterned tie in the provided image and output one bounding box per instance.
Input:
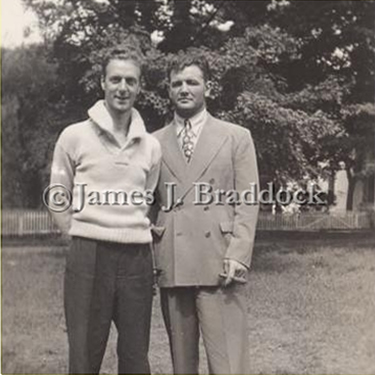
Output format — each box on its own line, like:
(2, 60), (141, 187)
(154, 55), (258, 374)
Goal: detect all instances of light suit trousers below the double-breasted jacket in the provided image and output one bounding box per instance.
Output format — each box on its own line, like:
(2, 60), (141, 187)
(161, 284), (249, 374)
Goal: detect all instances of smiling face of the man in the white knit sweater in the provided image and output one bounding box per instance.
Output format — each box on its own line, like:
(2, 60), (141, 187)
(101, 60), (141, 114)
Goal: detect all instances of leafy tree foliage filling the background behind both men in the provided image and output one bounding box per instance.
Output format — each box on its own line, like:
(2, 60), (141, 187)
(3, 0), (375, 209)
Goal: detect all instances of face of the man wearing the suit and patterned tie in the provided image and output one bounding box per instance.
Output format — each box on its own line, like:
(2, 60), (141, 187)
(169, 65), (209, 118)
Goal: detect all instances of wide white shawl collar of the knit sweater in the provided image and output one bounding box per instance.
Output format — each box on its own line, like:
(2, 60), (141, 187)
(88, 100), (146, 140)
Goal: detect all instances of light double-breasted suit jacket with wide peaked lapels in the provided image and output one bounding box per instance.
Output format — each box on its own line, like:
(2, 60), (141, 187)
(153, 115), (258, 287)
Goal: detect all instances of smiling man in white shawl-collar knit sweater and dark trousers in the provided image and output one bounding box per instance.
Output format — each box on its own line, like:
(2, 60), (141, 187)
(49, 48), (161, 374)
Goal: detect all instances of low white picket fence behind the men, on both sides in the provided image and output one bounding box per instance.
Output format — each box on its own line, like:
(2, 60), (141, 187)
(1, 210), (375, 237)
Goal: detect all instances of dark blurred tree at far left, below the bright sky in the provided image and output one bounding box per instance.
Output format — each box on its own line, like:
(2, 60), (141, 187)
(2, 46), (74, 207)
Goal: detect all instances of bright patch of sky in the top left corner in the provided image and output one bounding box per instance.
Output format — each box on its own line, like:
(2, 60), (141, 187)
(0, 0), (41, 48)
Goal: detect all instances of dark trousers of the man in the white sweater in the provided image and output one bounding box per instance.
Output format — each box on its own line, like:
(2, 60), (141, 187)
(64, 237), (153, 374)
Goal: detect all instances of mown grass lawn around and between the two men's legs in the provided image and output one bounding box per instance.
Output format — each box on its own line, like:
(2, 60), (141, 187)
(2, 235), (375, 374)
